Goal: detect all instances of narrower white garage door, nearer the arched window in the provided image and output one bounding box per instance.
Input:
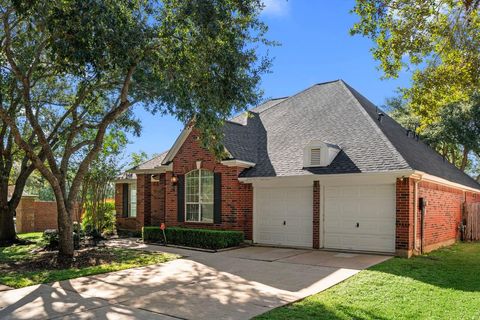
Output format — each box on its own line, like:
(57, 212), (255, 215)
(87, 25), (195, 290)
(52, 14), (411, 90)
(254, 187), (313, 247)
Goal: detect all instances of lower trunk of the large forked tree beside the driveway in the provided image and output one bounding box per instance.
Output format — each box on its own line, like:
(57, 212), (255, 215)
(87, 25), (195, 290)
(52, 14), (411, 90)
(57, 198), (74, 259)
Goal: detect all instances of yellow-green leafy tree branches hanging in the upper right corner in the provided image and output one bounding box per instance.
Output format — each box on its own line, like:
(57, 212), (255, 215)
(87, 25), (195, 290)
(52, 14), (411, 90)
(351, 0), (480, 122)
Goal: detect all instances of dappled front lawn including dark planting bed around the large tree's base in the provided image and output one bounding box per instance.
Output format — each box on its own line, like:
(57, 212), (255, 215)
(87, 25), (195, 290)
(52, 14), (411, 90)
(0, 232), (177, 288)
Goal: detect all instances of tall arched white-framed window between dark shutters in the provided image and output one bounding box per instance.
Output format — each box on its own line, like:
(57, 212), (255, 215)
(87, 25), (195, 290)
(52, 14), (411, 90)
(185, 169), (213, 223)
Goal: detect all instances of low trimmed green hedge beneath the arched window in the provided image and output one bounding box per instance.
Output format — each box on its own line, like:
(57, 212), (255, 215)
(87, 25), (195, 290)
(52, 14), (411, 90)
(142, 227), (244, 250)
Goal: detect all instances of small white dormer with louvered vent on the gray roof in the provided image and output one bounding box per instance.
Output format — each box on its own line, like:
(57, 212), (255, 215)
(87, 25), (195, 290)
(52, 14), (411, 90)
(303, 140), (341, 167)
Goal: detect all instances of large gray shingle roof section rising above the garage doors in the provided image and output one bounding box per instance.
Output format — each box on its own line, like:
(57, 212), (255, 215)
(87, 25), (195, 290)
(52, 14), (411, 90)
(234, 80), (480, 188)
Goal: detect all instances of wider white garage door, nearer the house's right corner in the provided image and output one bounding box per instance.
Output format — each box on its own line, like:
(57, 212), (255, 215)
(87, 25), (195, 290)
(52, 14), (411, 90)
(324, 185), (395, 252)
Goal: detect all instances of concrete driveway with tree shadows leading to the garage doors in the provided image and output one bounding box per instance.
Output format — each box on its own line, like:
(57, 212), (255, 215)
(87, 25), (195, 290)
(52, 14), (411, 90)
(0, 240), (389, 319)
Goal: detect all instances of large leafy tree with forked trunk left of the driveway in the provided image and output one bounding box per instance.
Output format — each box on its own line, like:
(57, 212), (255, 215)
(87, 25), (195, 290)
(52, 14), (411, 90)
(0, 0), (269, 257)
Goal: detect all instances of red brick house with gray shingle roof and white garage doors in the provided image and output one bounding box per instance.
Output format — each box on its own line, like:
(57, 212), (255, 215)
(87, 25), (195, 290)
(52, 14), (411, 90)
(116, 80), (480, 256)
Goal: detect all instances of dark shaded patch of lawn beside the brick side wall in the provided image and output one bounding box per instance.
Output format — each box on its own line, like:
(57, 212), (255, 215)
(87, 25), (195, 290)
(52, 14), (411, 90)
(369, 243), (480, 292)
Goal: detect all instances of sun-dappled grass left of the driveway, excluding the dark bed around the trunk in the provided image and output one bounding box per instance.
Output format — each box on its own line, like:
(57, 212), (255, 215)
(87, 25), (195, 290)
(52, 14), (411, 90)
(0, 232), (177, 288)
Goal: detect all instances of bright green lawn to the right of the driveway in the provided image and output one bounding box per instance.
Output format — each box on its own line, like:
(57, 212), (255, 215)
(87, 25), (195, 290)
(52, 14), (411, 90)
(257, 243), (480, 320)
